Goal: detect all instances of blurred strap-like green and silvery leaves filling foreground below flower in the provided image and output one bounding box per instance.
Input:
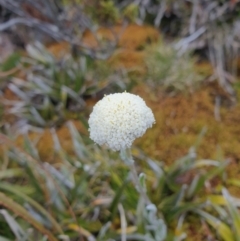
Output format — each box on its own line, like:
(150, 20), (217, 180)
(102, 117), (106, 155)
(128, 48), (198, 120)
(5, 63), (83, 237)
(0, 122), (240, 241)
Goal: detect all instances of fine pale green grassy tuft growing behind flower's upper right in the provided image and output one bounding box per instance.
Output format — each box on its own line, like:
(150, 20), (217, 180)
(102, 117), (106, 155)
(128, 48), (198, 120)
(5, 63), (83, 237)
(145, 41), (204, 92)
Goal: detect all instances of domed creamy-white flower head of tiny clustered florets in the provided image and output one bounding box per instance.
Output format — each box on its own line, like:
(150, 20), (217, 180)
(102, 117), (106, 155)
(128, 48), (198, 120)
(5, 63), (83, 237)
(88, 92), (155, 151)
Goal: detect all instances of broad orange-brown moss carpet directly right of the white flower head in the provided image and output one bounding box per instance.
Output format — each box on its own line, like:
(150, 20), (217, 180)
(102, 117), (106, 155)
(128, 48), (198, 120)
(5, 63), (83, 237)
(134, 85), (240, 174)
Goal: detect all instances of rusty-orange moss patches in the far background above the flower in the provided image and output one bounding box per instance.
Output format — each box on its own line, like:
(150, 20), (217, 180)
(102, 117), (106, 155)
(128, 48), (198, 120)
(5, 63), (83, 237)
(47, 24), (159, 74)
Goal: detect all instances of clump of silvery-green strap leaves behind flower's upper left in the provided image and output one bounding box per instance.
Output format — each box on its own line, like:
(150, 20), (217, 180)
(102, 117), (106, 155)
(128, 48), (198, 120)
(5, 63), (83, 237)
(4, 43), (125, 126)
